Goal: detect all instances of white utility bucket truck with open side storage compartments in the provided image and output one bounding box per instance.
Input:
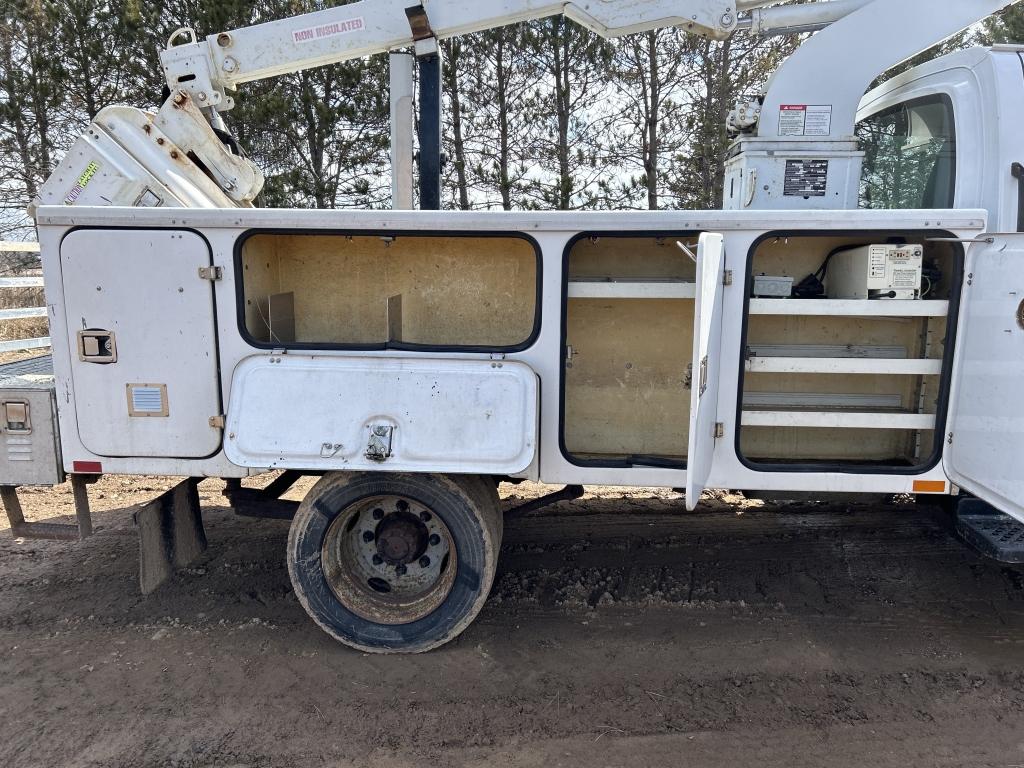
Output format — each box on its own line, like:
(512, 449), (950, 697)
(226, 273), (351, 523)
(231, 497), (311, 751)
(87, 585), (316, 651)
(0, 0), (1024, 651)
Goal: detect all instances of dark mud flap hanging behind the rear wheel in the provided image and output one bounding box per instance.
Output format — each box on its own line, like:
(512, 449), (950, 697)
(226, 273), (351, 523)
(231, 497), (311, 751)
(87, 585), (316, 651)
(134, 477), (206, 595)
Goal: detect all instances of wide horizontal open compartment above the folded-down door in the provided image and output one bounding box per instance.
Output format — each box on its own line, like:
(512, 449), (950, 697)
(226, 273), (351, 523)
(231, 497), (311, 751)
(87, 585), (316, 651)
(238, 232), (540, 350)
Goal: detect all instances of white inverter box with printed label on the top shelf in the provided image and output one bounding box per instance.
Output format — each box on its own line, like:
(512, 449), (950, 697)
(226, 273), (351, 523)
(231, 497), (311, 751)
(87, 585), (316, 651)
(825, 245), (925, 299)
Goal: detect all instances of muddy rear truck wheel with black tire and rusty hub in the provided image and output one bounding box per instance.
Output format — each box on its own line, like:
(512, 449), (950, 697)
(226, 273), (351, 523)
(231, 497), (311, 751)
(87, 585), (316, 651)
(288, 472), (502, 653)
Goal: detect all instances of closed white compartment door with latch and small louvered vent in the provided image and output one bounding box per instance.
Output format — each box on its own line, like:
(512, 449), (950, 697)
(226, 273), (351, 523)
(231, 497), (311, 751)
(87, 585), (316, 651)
(60, 229), (221, 459)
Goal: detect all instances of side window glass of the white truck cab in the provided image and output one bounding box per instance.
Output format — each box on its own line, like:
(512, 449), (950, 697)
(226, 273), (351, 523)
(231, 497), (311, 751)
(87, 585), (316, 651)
(857, 95), (956, 209)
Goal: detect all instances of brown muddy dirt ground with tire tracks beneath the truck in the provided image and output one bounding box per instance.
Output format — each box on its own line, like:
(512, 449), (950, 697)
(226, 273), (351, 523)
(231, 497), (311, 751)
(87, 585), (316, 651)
(0, 477), (1024, 768)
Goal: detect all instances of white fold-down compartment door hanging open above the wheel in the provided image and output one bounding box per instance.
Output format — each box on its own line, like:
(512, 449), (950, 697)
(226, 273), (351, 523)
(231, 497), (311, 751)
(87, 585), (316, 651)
(224, 354), (538, 474)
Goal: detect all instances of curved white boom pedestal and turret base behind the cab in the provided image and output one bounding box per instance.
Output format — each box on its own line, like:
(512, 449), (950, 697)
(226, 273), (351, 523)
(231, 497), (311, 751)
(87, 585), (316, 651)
(725, 0), (1019, 210)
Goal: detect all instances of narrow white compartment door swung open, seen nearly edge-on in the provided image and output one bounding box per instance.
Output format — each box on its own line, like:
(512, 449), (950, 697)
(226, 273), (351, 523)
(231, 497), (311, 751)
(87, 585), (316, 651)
(686, 232), (725, 511)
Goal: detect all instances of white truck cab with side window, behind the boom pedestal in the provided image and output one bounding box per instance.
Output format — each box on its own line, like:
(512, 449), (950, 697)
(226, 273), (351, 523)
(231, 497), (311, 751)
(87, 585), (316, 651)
(857, 45), (1024, 232)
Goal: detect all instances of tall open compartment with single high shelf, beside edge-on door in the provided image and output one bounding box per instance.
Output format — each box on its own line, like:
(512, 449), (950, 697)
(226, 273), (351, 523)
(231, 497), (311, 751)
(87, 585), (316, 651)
(562, 232), (696, 467)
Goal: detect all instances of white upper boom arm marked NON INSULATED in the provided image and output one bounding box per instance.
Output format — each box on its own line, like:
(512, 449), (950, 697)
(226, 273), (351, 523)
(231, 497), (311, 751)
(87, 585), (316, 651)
(161, 0), (737, 111)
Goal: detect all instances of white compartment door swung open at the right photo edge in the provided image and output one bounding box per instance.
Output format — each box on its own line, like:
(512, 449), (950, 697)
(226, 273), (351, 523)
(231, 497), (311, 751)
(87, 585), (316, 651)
(942, 234), (1024, 522)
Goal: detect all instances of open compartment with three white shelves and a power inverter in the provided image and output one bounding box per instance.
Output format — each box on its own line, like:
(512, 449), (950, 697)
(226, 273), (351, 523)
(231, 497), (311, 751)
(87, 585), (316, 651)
(737, 232), (963, 472)
